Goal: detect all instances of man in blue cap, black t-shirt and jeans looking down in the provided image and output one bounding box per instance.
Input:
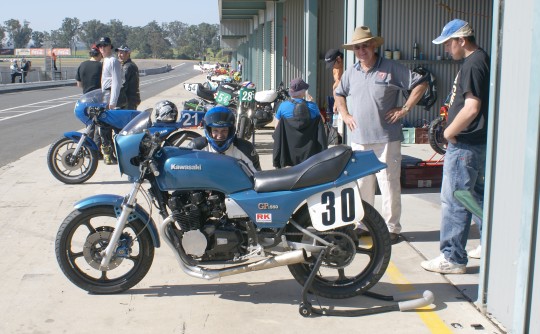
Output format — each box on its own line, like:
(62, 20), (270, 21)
(421, 19), (490, 274)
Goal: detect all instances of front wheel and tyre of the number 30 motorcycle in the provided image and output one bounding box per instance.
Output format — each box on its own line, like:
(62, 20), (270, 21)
(55, 206), (154, 294)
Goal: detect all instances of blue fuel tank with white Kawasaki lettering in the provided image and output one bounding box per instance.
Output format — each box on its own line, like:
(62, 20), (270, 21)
(156, 147), (253, 194)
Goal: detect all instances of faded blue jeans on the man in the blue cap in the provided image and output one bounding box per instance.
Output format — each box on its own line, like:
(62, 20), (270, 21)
(440, 143), (486, 264)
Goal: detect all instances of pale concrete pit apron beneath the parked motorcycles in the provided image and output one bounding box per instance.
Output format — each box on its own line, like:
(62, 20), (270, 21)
(0, 76), (504, 334)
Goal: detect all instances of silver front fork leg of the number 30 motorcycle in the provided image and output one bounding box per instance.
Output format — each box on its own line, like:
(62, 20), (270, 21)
(99, 178), (143, 270)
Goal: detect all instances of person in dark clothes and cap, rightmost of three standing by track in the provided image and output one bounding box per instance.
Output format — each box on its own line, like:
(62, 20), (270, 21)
(116, 45), (141, 110)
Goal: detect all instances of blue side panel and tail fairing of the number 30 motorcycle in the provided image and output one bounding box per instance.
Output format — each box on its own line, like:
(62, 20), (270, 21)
(229, 151), (386, 227)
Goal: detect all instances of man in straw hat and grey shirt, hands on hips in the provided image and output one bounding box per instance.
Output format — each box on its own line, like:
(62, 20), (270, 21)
(335, 26), (427, 243)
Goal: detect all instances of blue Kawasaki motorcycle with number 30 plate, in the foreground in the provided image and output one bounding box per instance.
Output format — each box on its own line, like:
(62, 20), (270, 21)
(55, 111), (432, 316)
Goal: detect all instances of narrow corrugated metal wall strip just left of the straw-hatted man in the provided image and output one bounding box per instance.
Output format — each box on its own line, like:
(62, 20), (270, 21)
(316, 0), (345, 107)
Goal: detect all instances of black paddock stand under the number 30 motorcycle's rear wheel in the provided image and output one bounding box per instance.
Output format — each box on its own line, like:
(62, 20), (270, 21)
(298, 249), (435, 317)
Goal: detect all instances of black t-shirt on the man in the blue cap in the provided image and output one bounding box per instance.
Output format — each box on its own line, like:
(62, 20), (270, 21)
(448, 48), (489, 144)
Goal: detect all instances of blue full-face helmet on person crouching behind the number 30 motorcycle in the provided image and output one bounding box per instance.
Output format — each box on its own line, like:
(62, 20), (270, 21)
(203, 106), (236, 153)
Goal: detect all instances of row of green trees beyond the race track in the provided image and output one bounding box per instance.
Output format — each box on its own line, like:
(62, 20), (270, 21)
(0, 17), (221, 59)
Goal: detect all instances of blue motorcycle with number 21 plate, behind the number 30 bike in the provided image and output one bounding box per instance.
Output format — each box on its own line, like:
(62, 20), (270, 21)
(47, 89), (204, 184)
